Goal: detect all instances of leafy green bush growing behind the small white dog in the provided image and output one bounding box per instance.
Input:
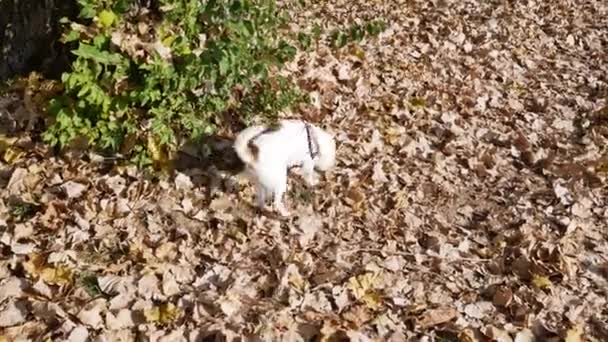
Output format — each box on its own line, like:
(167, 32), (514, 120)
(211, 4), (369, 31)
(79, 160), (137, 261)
(43, 0), (303, 166)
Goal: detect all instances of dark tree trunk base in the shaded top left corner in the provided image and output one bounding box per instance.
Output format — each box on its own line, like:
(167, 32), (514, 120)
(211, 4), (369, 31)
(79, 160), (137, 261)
(0, 0), (77, 81)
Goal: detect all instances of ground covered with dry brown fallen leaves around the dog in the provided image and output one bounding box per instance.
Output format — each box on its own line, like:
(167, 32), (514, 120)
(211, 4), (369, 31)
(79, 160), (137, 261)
(0, 0), (608, 342)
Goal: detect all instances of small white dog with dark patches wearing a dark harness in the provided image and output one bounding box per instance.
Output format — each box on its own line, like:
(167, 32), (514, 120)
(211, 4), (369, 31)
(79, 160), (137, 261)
(234, 120), (336, 216)
